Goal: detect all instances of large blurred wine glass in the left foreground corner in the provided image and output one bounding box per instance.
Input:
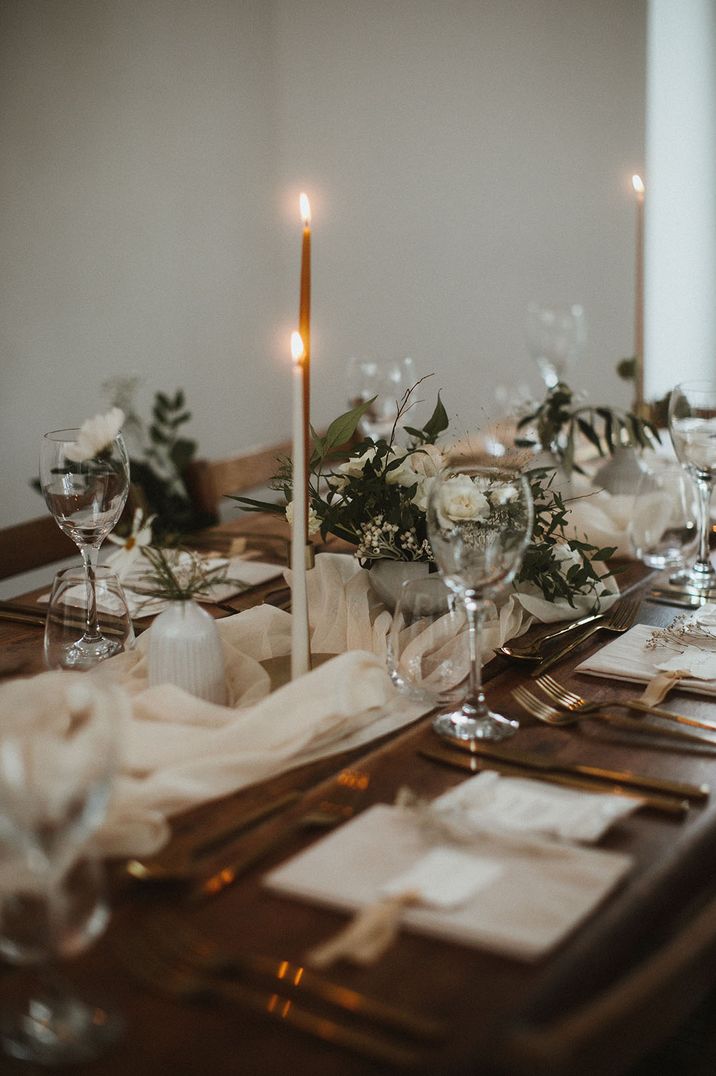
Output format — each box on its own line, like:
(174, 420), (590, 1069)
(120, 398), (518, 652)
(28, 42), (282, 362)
(0, 673), (124, 1064)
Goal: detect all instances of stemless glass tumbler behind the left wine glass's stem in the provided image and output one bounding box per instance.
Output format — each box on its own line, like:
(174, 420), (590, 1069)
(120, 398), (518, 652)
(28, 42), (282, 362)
(44, 567), (135, 669)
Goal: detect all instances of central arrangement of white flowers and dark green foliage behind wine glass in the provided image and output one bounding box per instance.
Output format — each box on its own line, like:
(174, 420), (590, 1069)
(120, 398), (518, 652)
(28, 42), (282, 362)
(234, 382), (615, 607)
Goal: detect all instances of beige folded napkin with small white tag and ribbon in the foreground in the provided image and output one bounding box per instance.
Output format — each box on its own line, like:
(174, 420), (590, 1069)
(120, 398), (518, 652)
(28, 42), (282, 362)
(264, 791), (631, 964)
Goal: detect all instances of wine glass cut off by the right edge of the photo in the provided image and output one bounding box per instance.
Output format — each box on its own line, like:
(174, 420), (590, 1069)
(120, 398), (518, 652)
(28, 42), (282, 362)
(669, 381), (716, 593)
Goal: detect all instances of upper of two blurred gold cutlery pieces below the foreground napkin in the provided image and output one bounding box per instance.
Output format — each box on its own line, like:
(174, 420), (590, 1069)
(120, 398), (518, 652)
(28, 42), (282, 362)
(132, 914), (445, 1042)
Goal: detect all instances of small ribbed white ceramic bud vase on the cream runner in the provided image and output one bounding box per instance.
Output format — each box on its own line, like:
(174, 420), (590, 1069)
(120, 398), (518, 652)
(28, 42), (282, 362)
(148, 599), (227, 706)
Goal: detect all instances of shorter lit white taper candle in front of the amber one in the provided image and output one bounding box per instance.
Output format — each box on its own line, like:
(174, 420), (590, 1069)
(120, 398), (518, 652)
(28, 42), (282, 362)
(291, 332), (310, 680)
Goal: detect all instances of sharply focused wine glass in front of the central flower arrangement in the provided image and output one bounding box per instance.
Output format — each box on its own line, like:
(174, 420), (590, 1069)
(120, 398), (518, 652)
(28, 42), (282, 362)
(427, 463), (534, 740)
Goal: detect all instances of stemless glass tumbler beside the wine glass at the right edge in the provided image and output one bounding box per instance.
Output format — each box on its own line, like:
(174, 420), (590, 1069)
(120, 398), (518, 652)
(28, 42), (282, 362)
(628, 462), (699, 568)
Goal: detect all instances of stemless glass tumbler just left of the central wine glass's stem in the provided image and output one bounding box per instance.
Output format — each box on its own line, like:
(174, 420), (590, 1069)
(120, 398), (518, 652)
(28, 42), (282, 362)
(387, 575), (469, 706)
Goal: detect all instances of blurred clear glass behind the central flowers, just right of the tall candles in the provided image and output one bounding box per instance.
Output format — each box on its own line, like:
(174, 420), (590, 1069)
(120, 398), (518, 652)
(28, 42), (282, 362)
(347, 358), (418, 441)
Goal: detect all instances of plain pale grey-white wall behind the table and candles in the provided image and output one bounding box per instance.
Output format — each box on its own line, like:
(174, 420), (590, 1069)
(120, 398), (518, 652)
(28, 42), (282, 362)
(0, 0), (645, 523)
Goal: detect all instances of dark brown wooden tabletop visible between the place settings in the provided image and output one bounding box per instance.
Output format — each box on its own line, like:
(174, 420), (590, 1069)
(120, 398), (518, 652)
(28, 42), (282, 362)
(0, 516), (716, 1076)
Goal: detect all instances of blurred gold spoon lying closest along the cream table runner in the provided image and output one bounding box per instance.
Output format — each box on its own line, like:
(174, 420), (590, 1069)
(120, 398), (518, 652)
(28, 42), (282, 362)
(124, 791), (301, 882)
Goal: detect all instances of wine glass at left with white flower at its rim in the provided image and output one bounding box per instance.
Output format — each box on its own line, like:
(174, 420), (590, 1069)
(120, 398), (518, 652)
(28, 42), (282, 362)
(40, 429), (129, 668)
